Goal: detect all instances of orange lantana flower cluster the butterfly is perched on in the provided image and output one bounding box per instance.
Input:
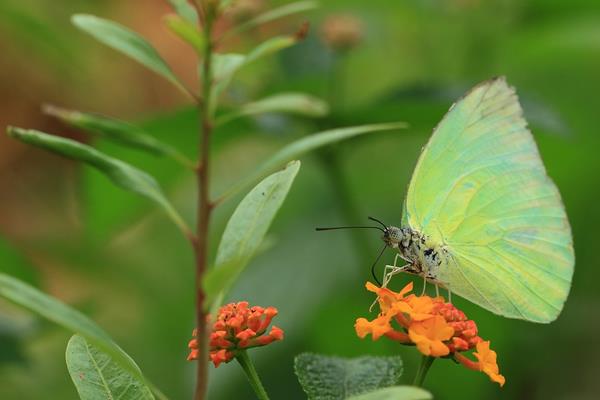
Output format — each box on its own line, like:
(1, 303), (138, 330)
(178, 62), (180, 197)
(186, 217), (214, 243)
(354, 282), (505, 386)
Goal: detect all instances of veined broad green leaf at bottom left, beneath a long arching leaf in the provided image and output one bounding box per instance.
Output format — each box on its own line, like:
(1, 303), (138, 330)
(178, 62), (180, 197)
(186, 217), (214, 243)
(66, 335), (154, 400)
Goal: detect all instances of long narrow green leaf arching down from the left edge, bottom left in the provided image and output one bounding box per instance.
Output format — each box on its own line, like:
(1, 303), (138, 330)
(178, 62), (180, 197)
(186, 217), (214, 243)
(0, 273), (164, 398)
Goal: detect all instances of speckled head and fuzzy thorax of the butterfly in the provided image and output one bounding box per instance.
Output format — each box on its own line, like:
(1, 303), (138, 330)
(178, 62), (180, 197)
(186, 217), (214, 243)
(383, 226), (448, 281)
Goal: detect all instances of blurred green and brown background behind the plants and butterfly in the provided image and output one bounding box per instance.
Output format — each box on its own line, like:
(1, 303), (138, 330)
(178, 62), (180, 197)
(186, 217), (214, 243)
(0, 0), (600, 399)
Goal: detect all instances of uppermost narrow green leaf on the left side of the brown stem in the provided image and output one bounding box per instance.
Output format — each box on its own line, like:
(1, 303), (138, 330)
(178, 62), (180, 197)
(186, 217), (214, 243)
(71, 14), (187, 93)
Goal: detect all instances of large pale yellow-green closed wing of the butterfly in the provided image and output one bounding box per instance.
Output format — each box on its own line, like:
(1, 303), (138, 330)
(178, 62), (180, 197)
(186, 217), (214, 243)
(403, 78), (574, 322)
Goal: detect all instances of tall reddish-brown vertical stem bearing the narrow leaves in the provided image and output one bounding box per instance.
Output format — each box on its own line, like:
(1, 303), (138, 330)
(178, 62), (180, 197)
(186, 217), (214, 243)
(194, 0), (214, 400)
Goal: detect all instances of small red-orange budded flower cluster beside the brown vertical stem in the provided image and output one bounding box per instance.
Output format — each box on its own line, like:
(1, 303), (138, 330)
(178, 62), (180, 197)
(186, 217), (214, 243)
(188, 301), (283, 367)
